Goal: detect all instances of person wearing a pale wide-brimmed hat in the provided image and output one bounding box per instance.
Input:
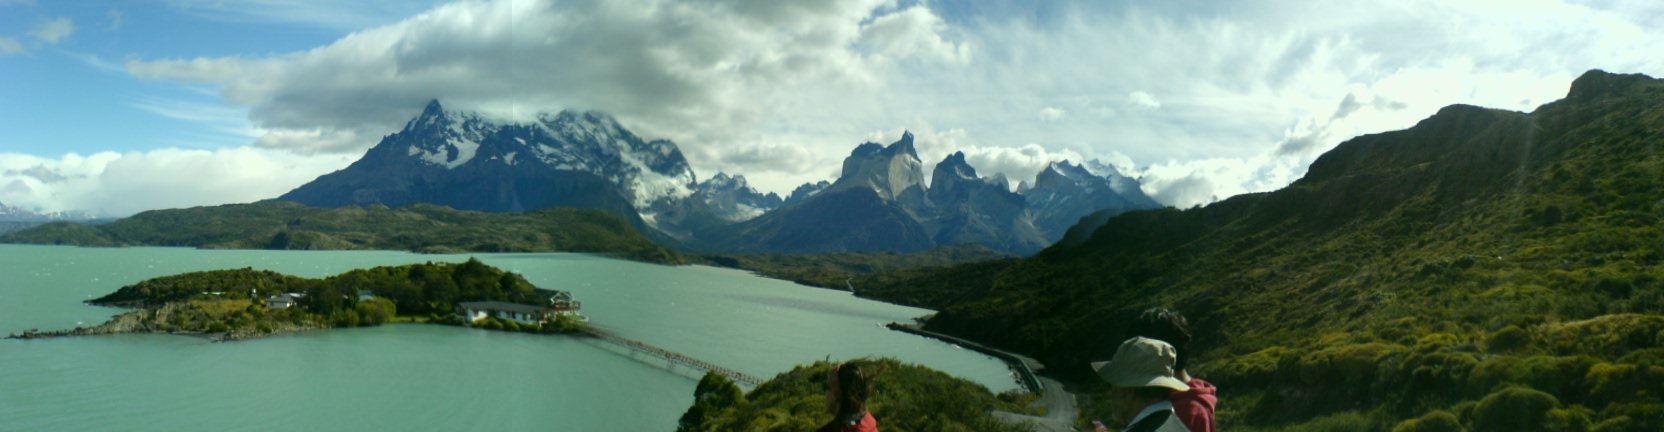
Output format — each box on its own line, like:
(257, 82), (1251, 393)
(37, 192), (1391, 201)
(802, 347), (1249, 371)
(1092, 337), (1190, 432)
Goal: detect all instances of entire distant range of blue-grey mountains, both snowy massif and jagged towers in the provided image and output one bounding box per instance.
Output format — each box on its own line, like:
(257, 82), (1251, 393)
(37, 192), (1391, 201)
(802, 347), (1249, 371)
(278, 101), (1160, 254)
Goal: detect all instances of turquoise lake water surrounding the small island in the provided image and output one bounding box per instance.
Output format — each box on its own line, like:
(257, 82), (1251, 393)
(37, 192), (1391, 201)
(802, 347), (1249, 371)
(0, 244), (1017, 430)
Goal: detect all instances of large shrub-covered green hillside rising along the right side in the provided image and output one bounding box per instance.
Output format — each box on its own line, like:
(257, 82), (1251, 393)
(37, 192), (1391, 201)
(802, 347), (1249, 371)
(864, 71), (1664, 430)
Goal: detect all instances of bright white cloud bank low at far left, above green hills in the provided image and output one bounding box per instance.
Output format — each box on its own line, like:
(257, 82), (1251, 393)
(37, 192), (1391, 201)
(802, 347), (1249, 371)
(0, 148), (353, 216)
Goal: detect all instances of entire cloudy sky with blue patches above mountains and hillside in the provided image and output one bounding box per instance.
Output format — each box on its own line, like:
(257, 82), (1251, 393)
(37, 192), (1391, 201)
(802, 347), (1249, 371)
(0, 0), (1664, 216)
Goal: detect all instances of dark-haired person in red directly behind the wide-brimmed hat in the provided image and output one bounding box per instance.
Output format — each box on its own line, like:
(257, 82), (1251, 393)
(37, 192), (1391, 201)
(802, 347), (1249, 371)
(1125, 307), (1220, 432)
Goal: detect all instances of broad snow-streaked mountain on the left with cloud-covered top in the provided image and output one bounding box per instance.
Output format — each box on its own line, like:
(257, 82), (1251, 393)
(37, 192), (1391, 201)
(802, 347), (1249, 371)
(285, 101), (697, 224)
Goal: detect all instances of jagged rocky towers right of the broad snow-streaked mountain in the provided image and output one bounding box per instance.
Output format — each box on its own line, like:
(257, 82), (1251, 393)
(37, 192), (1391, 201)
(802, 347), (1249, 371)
(707, 133), (1160, 254)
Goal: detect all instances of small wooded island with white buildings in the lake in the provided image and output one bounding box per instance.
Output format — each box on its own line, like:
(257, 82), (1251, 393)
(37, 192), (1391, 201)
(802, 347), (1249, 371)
(10, 258), (587, 341)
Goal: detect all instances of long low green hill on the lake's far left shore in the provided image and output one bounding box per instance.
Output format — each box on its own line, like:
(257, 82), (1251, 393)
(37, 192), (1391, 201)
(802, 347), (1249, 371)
(0, 201), (682, 264)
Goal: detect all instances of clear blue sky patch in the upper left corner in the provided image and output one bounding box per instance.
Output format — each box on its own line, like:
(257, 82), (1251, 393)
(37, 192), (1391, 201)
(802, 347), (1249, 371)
(0, 0), (442, 156)
